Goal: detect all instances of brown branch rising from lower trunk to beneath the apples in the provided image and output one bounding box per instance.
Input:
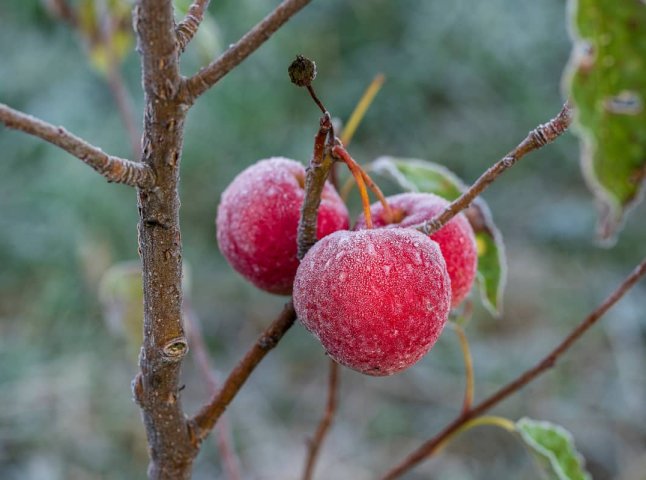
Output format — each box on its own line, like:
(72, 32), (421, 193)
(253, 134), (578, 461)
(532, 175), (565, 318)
(190, 302), (296, 444)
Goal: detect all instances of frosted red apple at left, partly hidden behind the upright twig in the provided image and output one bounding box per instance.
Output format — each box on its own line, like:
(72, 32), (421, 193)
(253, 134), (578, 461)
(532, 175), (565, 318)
(216, 157), (349, 295)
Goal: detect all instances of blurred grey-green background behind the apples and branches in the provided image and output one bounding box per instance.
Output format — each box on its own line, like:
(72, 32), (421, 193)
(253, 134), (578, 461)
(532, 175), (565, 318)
(0, 0), (646, 480)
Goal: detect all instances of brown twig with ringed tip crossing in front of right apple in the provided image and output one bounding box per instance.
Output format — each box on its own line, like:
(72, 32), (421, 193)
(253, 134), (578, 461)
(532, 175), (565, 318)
(417, 102), (572, 235)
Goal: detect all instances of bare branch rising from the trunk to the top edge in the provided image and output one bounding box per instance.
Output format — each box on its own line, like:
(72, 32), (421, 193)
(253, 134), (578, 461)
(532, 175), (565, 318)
(185, 0), (311, 103)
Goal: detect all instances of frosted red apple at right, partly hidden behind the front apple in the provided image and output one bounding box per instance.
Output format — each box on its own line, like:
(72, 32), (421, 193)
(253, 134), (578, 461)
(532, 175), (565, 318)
(355, 193), (478, 307)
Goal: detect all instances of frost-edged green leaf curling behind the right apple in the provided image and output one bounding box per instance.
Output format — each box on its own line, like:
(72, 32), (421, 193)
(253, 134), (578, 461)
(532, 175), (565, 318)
(368, 157), (507, 316)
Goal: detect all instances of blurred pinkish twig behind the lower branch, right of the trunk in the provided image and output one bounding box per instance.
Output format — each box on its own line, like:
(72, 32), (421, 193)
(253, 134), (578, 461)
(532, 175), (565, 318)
(184, 306), (242, 480)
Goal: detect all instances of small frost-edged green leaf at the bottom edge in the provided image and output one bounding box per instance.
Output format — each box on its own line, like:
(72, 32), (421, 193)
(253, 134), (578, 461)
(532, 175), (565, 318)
(516, 418), (592, 480)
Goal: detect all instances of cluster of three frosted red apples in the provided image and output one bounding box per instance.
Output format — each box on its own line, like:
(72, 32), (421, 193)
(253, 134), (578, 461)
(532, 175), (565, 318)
(216, 157), (478, 376)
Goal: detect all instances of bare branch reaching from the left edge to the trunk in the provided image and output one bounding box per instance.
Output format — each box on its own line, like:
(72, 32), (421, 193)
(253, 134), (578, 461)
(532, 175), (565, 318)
(0, 103), (155, 190)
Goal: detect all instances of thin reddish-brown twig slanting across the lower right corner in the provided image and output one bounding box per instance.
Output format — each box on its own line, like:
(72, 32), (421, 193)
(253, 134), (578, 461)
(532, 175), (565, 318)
(382, 259), (646, 480)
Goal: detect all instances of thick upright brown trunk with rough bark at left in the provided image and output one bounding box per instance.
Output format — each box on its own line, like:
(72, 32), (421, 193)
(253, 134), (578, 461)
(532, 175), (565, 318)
(133, 0), (198, 480)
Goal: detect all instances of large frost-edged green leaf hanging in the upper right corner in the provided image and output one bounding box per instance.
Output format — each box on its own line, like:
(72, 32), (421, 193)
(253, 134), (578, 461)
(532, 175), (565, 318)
(565, 0), (646, 241)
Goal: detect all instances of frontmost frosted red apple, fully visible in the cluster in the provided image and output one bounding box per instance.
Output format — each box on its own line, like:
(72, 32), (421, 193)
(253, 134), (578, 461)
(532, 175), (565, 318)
(294, 229), (451, 375)
